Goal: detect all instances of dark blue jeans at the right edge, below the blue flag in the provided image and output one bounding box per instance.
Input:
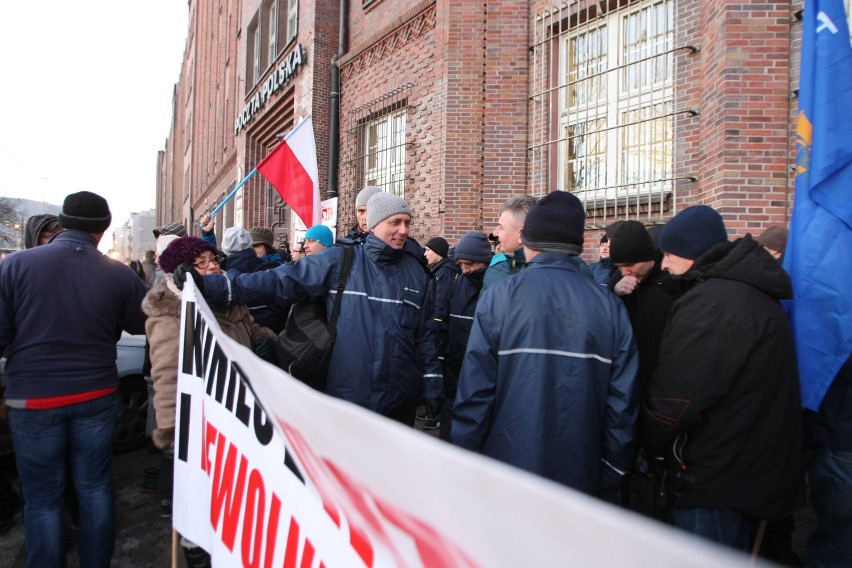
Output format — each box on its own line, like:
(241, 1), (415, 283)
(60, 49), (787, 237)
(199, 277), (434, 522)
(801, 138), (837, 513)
(805, 448), (852, 567)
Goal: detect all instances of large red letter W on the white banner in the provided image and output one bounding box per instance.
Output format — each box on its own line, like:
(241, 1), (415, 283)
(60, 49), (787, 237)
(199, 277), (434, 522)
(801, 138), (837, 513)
(210, 432), (248, 552)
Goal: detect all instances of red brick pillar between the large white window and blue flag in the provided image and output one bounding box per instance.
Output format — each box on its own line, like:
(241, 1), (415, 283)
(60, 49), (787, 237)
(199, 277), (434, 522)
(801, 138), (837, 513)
(675, 0), (791, 236)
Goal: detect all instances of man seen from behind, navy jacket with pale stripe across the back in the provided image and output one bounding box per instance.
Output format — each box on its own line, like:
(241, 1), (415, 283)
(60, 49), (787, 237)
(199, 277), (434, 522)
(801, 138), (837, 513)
(451, 191), (639, 499)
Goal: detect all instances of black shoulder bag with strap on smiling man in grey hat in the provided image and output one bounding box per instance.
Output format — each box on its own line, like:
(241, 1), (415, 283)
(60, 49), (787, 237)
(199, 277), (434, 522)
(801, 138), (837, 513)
(275, 245), (355, 391)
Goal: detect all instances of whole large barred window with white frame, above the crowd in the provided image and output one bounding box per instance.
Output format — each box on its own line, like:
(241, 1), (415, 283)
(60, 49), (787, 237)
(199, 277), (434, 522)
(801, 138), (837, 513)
(529, 0), (675, 224)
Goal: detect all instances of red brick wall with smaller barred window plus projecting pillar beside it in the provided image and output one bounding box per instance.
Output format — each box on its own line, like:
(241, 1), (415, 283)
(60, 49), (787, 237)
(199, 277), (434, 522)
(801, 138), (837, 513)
(339, 0), (528, 244)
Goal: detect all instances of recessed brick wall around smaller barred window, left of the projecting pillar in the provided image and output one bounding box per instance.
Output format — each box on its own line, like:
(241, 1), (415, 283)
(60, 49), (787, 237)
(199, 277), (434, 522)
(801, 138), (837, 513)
(338, 0), (444, 240)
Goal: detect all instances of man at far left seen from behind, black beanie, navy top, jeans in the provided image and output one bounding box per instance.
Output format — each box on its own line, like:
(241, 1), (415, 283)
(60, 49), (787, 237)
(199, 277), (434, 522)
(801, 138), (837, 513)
(0, 191), (146, 566)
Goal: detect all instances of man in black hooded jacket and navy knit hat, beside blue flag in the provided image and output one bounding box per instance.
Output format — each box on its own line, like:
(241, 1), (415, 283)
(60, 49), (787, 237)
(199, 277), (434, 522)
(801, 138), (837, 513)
(640, 205), (805, 550)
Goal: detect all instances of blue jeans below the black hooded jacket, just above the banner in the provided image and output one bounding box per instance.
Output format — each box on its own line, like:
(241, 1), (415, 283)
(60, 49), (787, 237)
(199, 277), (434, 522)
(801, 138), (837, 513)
(672, 507), (755, 552)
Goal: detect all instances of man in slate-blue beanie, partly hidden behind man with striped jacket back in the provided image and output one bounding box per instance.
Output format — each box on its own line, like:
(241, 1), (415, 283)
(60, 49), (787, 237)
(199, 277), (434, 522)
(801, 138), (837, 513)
(436, 232), (492, 442)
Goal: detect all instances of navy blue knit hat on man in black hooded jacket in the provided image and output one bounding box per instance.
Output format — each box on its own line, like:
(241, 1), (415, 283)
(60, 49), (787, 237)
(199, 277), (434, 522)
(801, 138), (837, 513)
(660, 205), (728, 260)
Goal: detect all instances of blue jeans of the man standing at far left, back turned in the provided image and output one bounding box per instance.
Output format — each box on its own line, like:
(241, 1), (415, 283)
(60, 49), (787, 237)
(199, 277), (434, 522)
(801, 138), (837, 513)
(9, 393), (119, 567)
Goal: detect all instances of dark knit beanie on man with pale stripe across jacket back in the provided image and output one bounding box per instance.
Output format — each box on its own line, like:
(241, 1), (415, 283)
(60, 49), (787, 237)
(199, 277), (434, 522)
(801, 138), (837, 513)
(521, 190), (586, 255)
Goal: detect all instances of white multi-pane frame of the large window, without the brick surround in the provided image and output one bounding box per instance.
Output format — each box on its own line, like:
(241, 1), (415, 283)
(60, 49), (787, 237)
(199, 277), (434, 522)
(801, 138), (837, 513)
(556, 0), (674, 208)
